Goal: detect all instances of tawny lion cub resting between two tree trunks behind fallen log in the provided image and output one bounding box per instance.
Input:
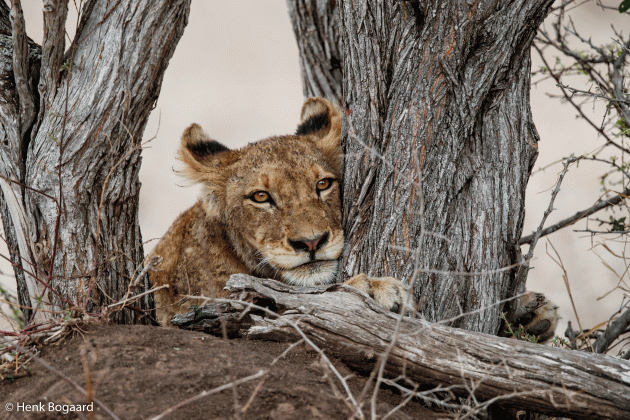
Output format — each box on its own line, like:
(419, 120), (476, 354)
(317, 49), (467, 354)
(151, 98), (406, 326)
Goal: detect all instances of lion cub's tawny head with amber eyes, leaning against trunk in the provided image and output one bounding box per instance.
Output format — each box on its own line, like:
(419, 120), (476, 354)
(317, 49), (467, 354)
(179, 98), (344, 285)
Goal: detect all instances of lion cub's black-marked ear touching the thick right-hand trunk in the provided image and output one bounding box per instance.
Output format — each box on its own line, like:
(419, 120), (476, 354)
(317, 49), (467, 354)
(295, 98), (341, 160)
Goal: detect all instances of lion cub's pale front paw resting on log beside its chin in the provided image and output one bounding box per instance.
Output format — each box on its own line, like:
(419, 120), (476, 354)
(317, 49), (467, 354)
(345, 273), (414, 315)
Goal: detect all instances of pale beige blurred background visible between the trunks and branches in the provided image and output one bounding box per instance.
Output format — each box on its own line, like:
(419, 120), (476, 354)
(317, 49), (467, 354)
(0, 0), (630, 350)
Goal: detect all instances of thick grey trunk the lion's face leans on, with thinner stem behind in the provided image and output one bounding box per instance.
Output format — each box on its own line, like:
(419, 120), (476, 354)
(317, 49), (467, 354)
(288, 0), (553, 333)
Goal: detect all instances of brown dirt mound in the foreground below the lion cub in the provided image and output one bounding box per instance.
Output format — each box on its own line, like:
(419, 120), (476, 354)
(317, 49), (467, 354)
(0, 324), (447, 420)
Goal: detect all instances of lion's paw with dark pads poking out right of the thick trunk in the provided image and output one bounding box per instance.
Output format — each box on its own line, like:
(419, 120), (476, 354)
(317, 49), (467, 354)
(508, 292), (560, 343)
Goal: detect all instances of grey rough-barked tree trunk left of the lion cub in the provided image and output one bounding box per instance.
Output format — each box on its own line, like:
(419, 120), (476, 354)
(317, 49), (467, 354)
(0, 0), (190, 323)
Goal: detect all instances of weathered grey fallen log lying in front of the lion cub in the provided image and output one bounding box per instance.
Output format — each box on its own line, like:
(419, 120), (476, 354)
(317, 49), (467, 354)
(173, 274), (630, 419)
